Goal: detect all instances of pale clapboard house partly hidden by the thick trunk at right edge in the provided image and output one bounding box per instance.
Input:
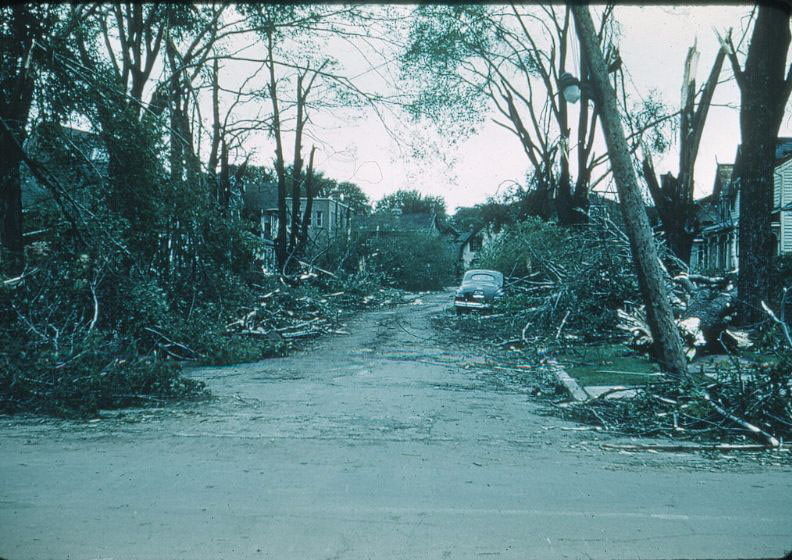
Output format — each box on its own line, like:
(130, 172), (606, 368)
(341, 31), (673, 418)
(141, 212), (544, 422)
(690, 138), (792, 274)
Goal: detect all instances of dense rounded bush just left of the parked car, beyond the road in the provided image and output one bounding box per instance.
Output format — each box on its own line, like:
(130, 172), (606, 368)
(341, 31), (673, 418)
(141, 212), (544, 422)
(366, 233), (456, 291)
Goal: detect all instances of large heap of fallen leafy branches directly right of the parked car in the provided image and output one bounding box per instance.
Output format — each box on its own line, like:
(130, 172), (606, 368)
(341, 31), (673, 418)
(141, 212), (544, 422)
(470, 215), (640, 344)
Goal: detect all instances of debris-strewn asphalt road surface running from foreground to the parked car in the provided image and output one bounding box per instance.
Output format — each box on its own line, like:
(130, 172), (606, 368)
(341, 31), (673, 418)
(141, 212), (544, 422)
(0, 294), (792, 560)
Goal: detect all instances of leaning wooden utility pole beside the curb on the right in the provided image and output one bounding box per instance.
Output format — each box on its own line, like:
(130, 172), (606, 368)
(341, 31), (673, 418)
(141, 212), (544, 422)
(569, 1), (687, 377)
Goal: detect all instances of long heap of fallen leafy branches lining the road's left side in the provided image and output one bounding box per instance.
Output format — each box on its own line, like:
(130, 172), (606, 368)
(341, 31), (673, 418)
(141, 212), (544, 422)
(0, 255), (402, 416)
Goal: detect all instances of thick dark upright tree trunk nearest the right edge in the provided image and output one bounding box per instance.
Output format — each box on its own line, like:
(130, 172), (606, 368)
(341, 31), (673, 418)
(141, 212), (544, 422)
(731, 3), (790, 325)
